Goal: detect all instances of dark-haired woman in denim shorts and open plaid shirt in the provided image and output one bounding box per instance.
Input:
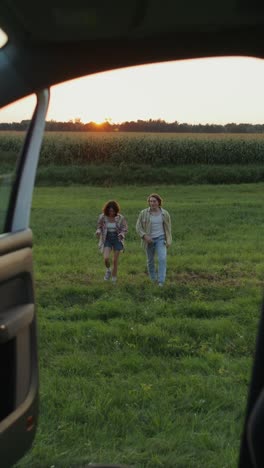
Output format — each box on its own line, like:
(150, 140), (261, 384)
(96, 200), (128, 283)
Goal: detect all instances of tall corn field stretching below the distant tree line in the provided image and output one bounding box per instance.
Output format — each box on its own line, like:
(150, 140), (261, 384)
(0, 132), (264, 167)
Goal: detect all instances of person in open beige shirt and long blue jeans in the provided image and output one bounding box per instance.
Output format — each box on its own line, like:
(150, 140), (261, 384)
(136, 193), (172, 286)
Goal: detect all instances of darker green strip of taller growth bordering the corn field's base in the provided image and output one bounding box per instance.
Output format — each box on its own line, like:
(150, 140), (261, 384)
(36, 163), (264, 187)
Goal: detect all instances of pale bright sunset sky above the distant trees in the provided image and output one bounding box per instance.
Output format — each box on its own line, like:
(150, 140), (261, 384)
(0, 57), (264, 124)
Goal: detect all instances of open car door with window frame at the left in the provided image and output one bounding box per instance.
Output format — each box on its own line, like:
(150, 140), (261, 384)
(0, 90), (49, 468)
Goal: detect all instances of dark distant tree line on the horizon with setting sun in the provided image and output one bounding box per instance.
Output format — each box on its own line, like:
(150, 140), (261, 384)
(0, 118), (264, 133)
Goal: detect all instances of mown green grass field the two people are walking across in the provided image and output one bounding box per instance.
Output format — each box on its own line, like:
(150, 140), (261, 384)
(18, 183), (264, 468)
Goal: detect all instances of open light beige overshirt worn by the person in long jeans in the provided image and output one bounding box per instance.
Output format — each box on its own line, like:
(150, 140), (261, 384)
(136, 208), (172, 248)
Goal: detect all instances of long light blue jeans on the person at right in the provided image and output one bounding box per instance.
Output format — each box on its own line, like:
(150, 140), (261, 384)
(147, 236), (167, 283)
